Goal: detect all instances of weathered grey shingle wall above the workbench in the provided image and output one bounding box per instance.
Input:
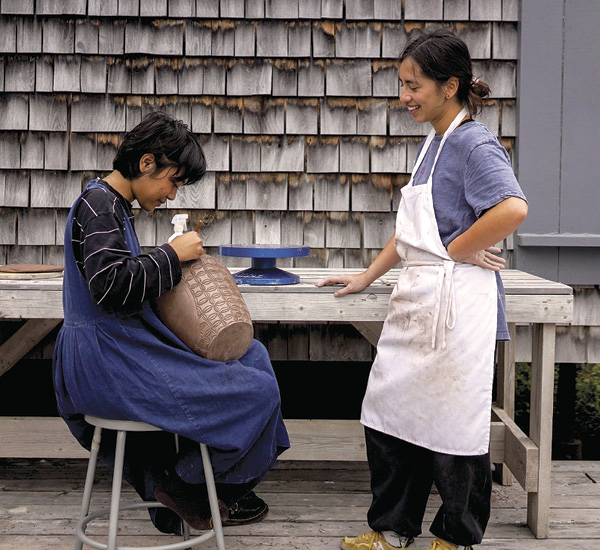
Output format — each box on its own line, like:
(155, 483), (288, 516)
(0, 0), (518, 267)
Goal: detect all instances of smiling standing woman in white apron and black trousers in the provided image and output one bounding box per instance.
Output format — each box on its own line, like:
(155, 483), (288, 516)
(319, 30), (527, 550)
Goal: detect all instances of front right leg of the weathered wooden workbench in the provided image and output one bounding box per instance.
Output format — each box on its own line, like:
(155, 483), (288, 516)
(527, 323), (556, 539)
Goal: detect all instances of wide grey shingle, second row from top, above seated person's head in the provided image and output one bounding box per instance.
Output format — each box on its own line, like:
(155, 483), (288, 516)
(125, 20), (183, 55)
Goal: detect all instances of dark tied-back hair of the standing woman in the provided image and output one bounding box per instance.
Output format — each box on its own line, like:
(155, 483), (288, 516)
(400, 29), (490, 116)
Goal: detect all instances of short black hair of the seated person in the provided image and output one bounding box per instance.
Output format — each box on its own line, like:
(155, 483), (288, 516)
(113, 111), (206, 183)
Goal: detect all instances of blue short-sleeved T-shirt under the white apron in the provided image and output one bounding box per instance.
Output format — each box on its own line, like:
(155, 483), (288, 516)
(413, 121), (525, 340)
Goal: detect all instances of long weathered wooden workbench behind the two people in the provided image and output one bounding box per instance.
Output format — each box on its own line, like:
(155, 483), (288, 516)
(0, 268), (573, 538)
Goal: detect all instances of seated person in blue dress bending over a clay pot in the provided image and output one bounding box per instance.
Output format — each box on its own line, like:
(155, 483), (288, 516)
(54, 112), (289, 533)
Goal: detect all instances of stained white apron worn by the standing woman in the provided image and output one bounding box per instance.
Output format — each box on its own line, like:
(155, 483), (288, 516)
(361, 109), (497, 455)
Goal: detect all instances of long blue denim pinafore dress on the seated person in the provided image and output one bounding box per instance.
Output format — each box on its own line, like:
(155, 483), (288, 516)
(53, 180), (289, 532)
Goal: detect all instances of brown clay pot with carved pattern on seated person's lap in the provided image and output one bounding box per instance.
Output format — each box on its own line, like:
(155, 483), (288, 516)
(158, 254), (254, 361)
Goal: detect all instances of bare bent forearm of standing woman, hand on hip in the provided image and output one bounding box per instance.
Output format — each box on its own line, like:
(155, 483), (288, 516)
(448, 197), (527, 261)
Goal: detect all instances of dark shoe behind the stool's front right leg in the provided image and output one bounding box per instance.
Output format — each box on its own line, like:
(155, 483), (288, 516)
(154, 475), (227, 531)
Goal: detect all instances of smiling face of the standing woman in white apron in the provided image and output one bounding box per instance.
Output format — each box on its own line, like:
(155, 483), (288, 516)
(400, 57), (461, 135)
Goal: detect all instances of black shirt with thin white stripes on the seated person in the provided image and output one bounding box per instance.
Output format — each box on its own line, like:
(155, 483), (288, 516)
(72, 181), (181, 311)
